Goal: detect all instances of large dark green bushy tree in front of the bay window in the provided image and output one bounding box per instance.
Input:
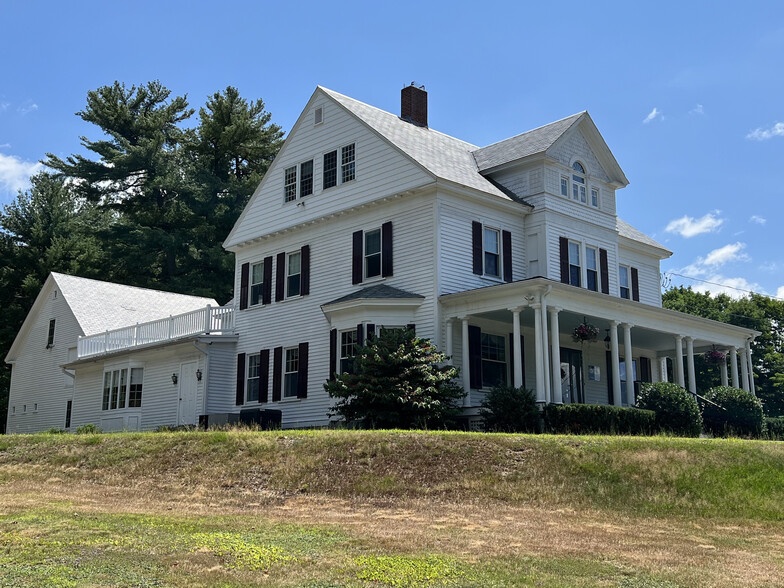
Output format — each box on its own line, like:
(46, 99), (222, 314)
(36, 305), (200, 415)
(324, 329), (464, 429)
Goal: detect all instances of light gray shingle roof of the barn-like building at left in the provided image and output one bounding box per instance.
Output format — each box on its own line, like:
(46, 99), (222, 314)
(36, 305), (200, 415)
(52, 272), (220, 335)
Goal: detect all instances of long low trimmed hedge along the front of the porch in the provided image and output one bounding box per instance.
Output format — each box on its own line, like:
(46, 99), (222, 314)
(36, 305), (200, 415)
(544, 404), (656, 435)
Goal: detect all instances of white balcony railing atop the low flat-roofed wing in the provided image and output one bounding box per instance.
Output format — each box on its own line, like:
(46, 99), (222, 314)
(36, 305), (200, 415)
(77, 305), (234, 359)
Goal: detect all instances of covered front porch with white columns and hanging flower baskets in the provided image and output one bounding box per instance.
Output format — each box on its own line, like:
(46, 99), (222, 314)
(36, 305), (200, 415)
(439, 278), (757, 409)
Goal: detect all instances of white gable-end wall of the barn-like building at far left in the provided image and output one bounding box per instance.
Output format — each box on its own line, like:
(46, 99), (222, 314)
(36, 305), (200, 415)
(7, 278), (82, 433)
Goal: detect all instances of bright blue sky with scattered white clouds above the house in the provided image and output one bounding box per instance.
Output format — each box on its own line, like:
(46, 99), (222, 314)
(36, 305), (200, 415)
(0, 0), (784, 298)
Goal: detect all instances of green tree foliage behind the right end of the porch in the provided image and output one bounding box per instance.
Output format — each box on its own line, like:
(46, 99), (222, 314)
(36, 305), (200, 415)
(662, 287), (784, 415)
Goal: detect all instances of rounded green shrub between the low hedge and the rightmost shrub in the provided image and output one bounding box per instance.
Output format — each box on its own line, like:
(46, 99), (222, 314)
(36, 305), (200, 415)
(637, 382), (702, 437)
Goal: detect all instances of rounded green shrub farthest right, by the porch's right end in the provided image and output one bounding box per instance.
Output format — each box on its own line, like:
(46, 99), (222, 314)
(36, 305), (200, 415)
(702, 386), (764, 437)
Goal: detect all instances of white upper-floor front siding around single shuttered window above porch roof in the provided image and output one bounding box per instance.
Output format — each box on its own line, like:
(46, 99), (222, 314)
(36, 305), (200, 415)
(438, 194), (526, 295)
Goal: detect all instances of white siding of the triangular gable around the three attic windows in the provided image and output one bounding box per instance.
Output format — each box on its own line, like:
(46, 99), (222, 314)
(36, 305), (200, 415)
(227, 90), (433, 249)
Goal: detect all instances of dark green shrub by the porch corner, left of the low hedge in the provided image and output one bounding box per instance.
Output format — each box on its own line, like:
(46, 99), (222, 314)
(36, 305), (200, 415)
(479, 386), (539, 433)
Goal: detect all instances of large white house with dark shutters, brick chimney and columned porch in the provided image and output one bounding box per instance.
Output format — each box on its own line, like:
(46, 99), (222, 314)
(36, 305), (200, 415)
(3, 85), (756, 428)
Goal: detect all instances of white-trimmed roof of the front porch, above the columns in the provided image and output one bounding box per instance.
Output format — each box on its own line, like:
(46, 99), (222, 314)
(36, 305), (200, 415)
(439, 277), (760, 351)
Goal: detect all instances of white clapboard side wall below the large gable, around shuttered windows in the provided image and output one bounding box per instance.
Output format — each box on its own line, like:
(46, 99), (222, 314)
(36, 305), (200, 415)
(231, 195), (436, 426)
